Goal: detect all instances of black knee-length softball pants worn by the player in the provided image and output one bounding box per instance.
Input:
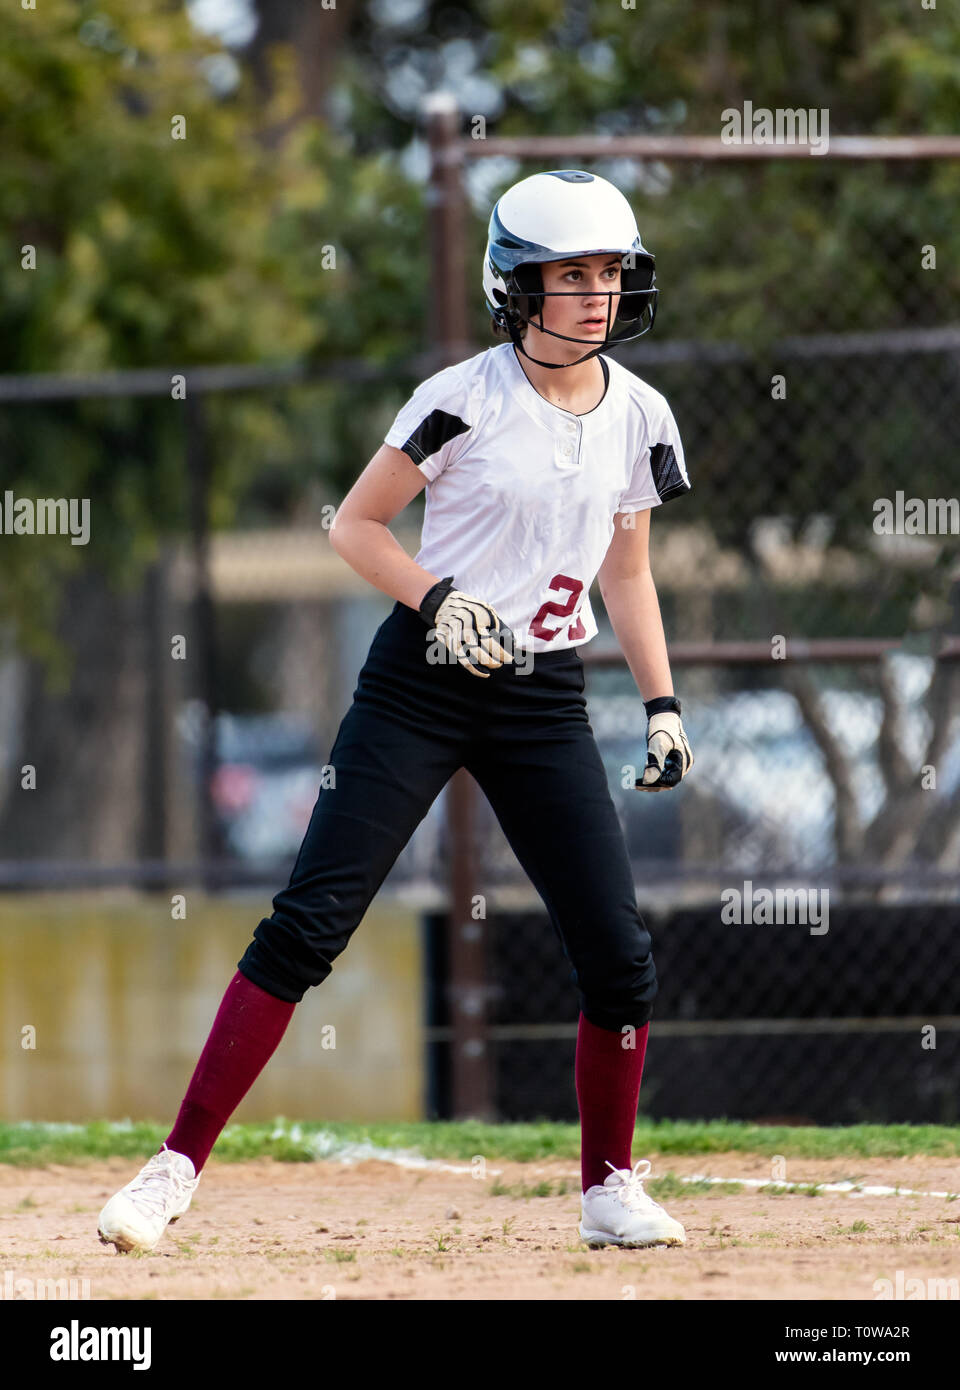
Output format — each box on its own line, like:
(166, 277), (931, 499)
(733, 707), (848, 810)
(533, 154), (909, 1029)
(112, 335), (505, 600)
(239, 603), (657, 1030)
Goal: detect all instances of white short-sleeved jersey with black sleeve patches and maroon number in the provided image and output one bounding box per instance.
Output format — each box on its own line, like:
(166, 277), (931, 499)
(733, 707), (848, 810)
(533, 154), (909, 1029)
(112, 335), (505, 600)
(385, 343), (690, 652)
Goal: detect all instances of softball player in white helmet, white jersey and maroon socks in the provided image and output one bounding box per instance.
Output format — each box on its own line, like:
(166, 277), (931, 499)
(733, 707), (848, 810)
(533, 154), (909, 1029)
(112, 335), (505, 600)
(99, 170), (693, 1251)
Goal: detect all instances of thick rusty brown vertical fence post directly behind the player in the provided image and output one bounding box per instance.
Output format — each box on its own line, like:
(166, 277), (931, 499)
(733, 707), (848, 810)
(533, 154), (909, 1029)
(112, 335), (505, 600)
(424, 92), (495, 1119)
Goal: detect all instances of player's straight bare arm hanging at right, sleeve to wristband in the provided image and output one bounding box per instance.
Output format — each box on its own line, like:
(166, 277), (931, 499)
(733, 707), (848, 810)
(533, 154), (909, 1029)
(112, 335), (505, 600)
(597, 510), (674, 701)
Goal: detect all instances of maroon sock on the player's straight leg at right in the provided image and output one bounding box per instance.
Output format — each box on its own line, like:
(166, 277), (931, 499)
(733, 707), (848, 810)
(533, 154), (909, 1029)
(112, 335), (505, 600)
(575, 1013), (650, 1191)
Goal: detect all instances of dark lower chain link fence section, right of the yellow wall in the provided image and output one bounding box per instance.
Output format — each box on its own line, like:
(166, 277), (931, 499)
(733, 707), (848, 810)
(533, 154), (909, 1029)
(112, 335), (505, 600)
(428, 900), (960, 1125)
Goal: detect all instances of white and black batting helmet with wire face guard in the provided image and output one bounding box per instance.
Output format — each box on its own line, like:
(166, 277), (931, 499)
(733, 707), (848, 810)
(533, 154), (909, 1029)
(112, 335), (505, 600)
(483, 170), (657, 368)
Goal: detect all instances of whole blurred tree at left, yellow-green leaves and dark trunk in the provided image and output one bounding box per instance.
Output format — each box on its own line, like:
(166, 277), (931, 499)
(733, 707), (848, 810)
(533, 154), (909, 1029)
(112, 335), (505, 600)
(0, 0), (418, 858)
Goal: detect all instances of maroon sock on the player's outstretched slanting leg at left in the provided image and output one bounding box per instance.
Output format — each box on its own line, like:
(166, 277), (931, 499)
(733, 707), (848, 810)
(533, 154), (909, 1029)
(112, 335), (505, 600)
(167, 970), (296, 1173)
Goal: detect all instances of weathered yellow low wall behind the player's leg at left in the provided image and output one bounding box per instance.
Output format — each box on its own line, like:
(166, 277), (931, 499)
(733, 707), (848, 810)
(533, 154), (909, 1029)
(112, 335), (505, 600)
(0, 891), (424, 1123)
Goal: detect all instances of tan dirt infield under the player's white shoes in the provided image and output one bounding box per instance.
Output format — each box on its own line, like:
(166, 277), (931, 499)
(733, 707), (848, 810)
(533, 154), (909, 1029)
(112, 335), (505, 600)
(0, 1154), (960, 1301)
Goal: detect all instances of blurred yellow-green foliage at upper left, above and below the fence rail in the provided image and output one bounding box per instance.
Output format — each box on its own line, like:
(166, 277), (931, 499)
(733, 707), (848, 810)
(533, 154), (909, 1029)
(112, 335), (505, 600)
(0, 0), (420, 639)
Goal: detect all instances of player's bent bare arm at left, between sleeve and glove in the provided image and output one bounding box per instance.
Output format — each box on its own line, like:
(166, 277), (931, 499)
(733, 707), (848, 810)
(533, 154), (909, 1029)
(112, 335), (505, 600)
(329, 443), (443, 612)
